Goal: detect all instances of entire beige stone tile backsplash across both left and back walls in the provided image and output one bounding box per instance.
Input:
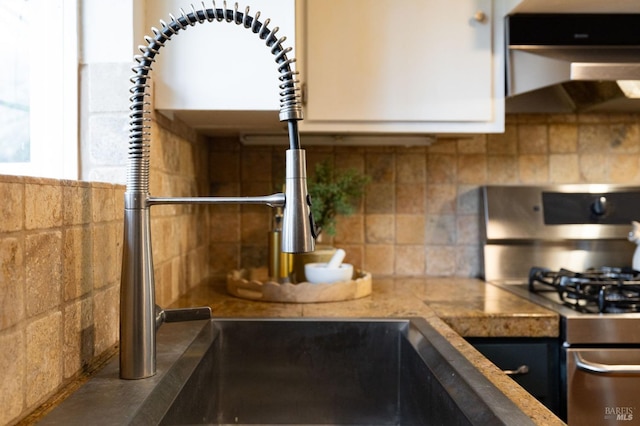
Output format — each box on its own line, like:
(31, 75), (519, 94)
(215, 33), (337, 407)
(0, 114), (640, 425)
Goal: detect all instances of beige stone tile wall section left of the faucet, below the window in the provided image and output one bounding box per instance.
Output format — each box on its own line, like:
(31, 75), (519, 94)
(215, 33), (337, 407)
(0, 176), (124, 424)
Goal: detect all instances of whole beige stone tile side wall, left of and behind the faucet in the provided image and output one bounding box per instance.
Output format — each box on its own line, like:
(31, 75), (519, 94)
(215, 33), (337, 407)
(0, 117), (209, 425)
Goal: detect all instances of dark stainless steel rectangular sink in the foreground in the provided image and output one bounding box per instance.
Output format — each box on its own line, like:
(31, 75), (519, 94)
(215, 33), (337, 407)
(38, 319), (532, 425)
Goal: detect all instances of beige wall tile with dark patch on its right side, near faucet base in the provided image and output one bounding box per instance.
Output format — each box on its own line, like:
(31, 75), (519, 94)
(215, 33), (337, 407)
(62, 298), (95, 379)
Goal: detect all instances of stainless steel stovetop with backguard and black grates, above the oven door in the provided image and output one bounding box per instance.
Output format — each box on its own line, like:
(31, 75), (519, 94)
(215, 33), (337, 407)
(482, 184), (640, 345)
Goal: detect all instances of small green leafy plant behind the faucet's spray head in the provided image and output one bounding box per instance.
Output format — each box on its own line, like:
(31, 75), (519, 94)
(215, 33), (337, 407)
(307, 160), (371, 236)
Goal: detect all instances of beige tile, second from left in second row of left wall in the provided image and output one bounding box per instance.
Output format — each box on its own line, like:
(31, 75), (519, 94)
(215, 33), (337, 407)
(25, 231), (62, 317)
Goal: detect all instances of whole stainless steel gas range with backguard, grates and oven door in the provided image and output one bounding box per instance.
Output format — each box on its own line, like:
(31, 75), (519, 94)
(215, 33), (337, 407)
(483, 185), (640, 425)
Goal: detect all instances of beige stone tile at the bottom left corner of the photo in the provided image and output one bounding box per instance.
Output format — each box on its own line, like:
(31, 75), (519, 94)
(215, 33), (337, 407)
(0, 329), (26, 425)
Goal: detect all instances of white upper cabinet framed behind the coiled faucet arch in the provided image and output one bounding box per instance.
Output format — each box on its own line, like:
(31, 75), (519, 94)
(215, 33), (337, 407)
(145, 0), (295, 132)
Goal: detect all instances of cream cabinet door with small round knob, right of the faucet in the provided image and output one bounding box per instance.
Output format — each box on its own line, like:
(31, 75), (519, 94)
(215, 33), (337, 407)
(297, 0), (504, 131)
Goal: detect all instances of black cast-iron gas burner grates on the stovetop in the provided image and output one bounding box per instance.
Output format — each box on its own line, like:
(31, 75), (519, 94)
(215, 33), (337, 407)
(529, 267), (640, 313)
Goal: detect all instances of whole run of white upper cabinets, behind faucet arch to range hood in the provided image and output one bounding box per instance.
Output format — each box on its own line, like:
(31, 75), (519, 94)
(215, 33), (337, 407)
(146, 0), (512, 134)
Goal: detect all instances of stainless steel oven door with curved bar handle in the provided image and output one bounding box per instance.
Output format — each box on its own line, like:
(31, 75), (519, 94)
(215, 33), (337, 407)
(567, 347), (640, 426)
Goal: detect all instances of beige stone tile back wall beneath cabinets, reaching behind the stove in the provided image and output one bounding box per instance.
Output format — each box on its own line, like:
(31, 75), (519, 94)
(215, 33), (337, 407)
(210, 114), (640, 276)
